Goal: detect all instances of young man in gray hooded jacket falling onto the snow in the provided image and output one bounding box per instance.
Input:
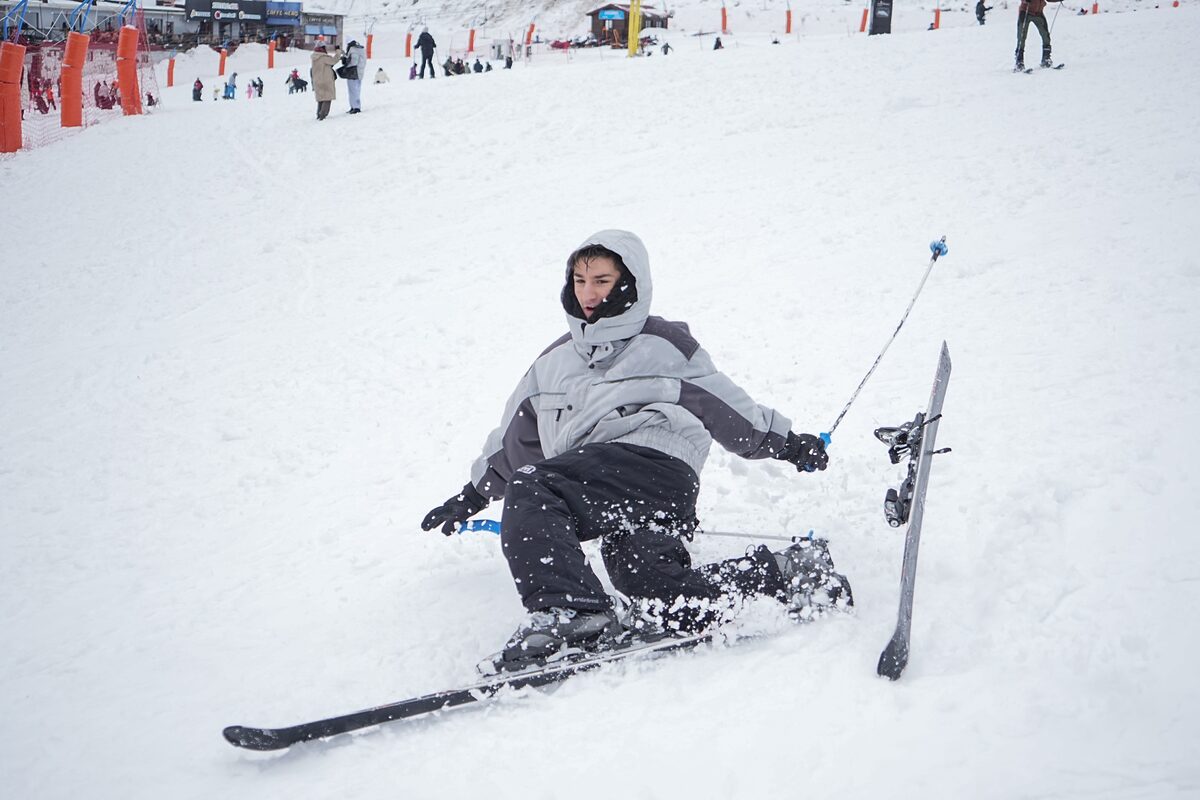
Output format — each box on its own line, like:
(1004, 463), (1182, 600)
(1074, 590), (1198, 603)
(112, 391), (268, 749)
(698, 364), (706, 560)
(421, 230), (853, 669)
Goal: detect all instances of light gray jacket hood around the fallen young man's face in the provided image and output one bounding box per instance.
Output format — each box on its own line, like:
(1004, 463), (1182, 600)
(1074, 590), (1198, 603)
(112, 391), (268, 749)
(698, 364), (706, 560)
(562, 230), (653, 347)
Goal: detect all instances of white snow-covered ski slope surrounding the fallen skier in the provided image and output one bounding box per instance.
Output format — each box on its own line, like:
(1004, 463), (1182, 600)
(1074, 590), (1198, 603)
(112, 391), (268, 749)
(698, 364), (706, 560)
(0, 6), (1200, 799)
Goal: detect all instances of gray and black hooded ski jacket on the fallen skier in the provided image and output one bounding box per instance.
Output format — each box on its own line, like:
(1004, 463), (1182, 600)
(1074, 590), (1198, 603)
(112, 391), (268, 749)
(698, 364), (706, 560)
(470, 230), (792, 499)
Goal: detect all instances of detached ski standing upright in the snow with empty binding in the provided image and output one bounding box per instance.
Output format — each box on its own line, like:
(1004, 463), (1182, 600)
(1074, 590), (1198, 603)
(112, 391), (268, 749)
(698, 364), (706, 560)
(875, 342), (950, 680)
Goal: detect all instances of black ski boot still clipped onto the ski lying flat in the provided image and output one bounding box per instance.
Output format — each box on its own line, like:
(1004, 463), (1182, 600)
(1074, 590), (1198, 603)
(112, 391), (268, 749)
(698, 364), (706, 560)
(479, 607), (624, 673)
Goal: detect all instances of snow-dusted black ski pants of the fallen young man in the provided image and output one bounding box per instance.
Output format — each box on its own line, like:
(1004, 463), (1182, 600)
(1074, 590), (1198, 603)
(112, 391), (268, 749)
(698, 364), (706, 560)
(500, 443), (784, 628)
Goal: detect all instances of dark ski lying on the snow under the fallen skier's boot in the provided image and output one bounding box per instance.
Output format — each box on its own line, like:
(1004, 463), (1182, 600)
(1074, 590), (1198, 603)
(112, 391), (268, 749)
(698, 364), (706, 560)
(222, 633), (714, 751)
